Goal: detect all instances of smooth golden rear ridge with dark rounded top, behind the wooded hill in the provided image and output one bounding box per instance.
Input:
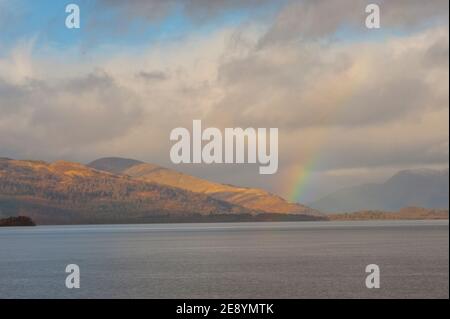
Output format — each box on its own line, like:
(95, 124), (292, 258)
(88, 158), (320, 215)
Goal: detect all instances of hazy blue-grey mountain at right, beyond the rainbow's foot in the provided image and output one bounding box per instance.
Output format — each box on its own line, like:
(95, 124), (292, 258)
(309, 169), (449, 212)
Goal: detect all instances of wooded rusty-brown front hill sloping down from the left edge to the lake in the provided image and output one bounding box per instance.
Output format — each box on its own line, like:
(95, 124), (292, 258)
(0, 158), (316, 224)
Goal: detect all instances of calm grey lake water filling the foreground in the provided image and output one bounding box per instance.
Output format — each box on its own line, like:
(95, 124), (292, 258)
(0, 221), (449, 298)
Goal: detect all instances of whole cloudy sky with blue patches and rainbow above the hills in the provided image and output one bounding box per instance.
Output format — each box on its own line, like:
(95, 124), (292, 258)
(0, 0), (449, 203)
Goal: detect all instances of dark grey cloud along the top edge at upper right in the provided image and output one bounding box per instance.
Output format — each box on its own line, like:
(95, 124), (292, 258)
(259, 0), (449, 48)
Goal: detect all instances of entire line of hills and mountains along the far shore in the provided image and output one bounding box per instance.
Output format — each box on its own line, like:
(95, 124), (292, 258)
(0, 157), (449, 224)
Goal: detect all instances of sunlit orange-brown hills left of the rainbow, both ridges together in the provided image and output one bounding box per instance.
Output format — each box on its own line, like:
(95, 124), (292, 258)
(0, 158), (323, 224)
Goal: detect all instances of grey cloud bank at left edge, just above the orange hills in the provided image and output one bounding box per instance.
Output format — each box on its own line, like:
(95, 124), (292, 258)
(0, 66), (143, 157)
